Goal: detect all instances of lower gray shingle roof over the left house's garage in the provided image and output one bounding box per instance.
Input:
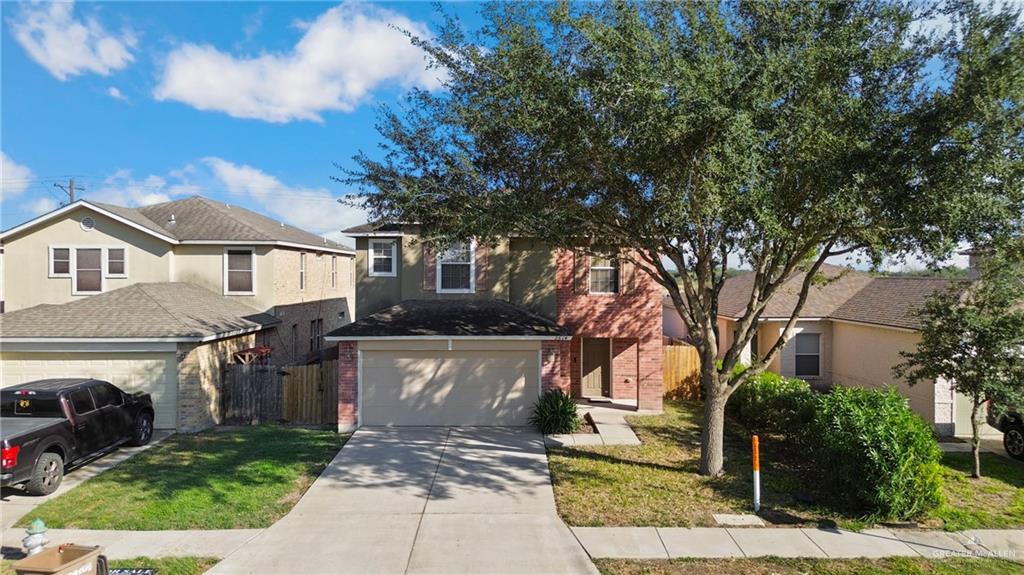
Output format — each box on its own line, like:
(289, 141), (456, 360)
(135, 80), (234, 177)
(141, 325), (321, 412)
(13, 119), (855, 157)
(0, 282), (281, 341)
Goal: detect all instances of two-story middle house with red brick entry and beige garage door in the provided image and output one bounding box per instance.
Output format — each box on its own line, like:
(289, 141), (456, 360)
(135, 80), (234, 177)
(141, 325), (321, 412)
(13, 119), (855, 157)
(327, 225), (663, 429)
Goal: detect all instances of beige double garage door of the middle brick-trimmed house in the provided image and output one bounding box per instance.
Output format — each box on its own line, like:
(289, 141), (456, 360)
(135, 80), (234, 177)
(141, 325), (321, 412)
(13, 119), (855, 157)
(361, 350), (540, 426)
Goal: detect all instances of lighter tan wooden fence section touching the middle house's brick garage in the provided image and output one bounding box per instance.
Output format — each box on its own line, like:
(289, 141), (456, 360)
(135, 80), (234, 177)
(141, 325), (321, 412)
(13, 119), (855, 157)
(282, 360), (338, 426)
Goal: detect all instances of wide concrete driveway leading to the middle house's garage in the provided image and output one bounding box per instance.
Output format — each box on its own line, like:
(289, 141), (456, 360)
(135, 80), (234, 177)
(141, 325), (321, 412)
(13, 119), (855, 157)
(209, 428), (597, 575)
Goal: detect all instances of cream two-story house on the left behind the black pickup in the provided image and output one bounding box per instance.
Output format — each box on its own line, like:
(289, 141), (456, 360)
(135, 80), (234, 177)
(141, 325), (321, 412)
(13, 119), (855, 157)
(0, 196), (354, 430)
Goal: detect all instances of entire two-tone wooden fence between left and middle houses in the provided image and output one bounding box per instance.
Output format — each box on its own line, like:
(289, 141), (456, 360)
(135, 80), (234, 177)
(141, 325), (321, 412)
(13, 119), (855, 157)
(220, 360), (338, 426)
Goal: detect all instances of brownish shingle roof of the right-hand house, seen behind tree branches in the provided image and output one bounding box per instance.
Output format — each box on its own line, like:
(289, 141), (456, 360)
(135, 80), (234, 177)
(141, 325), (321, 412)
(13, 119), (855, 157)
(719, 265), (958, 329)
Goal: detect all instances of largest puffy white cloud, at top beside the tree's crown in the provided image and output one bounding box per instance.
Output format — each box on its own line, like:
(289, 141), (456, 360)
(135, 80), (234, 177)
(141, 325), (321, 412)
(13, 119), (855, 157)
(154, 2), (440, 123)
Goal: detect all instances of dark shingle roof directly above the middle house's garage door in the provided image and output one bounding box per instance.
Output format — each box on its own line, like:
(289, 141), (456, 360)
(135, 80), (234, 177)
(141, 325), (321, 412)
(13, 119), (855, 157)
(328, 300), (569, 339)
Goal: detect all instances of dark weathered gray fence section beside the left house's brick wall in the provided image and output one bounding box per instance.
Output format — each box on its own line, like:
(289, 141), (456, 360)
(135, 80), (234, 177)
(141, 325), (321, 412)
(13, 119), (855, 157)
(220, 363), (282, 426)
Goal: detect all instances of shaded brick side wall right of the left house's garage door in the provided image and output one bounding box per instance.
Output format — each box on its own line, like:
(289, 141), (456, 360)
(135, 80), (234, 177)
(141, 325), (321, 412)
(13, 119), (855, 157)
(177, 334), (256, 432)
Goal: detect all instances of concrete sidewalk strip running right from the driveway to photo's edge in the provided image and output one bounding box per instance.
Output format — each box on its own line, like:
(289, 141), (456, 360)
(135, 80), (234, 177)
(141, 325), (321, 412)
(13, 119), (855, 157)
(572, 527), (1024, 561)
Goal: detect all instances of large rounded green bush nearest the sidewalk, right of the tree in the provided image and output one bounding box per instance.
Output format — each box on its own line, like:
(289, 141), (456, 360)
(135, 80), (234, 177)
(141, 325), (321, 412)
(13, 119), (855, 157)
(808, 387), (942, 520)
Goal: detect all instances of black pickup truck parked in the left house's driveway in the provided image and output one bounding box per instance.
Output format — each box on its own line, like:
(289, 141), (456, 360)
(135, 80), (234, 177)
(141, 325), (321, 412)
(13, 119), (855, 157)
(0, 378), (154, 495)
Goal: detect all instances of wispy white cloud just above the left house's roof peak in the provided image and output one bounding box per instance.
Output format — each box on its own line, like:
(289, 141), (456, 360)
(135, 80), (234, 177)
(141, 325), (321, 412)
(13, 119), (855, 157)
(203, 158), (367, 235)
